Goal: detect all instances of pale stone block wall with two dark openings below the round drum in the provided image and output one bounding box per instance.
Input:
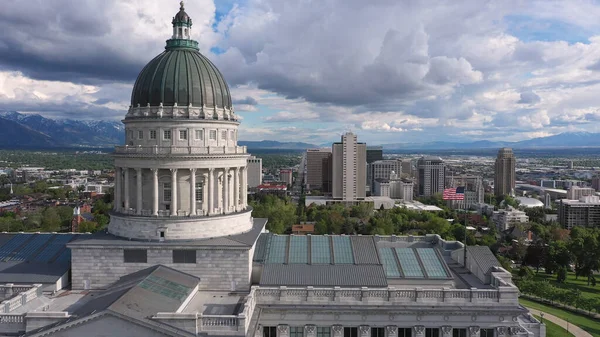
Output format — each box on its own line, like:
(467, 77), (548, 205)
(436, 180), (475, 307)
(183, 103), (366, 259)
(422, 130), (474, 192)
(71, 246), (252, 291)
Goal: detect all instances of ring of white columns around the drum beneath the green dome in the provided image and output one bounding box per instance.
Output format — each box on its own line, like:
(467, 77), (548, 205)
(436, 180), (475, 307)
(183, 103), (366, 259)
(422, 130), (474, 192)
(114, 166), (248, 216)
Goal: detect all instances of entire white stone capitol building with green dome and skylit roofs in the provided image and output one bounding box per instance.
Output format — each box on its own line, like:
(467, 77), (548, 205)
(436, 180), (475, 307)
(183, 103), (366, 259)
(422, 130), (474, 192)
(0, 3), (546, 337)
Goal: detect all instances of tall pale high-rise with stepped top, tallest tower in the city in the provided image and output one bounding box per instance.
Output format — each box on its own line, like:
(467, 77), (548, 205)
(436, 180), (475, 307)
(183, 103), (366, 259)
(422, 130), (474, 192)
(331, 132), (367, 200)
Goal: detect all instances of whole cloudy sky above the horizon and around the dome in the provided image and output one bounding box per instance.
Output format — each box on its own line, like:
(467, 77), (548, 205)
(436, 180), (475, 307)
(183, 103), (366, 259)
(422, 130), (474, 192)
(0, 0), (600, 145)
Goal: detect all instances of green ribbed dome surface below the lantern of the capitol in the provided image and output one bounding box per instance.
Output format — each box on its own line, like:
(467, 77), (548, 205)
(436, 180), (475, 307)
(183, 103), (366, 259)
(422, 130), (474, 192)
(131, 48), (232, 108)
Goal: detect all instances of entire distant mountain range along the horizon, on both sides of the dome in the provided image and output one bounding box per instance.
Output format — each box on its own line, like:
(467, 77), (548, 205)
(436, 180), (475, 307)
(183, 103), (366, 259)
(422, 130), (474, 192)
(0, 111), (600, 151)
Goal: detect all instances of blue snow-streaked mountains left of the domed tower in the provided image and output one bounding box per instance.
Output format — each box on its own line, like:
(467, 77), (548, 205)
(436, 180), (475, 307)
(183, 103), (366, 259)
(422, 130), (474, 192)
(0, 111), (125, 148)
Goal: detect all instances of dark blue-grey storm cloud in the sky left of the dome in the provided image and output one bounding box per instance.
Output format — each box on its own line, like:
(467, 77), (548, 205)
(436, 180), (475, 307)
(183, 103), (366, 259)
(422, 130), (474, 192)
(0, 0), (159, 84)
